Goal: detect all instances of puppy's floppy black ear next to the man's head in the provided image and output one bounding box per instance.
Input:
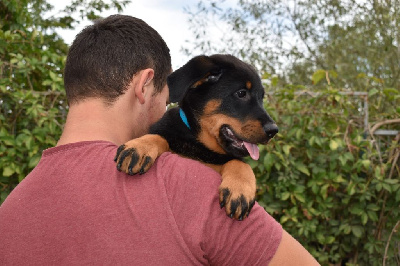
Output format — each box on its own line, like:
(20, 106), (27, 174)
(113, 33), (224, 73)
(167, 55), (222, 102)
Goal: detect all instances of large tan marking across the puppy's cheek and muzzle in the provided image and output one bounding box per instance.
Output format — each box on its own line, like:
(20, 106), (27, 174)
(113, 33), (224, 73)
(198, 100), (266, 154)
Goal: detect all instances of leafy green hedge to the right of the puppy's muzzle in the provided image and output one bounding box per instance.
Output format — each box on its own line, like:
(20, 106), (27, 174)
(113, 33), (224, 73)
(248, 86), (400, 265)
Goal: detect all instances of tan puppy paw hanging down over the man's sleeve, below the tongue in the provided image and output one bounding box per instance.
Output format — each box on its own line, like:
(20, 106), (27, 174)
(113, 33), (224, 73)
(219, 160), (256, 220)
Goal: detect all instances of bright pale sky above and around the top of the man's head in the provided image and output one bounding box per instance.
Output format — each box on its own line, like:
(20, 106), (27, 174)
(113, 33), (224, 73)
(49, 0), (203, 69)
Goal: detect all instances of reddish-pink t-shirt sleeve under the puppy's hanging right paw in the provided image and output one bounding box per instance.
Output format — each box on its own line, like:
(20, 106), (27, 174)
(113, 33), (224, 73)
(158, 155), (282, 265)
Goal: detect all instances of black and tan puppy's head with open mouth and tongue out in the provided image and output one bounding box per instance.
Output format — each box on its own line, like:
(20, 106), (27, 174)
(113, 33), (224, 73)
(167, 55), (278, 159)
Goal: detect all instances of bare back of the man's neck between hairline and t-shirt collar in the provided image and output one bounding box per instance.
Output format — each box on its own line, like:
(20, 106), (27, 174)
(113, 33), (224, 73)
(57, 99), (135, 146)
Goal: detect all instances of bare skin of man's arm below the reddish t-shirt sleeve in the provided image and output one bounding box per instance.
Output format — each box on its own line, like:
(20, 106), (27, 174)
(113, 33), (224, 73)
(269, 230), (320, 266)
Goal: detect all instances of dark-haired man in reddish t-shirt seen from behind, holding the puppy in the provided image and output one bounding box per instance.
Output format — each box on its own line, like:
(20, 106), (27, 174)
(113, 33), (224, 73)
(0, 15), (317, 265)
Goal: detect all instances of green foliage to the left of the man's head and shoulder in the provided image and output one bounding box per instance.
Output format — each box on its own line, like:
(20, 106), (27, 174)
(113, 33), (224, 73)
(0, 0), (129, 200)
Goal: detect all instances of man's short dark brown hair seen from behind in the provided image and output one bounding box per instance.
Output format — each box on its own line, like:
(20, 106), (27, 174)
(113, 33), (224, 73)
(64, 15), (171, 105)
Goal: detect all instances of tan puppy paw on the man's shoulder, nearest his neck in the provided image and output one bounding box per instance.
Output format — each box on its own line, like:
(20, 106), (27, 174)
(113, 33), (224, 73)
(114, 134), (169, 175)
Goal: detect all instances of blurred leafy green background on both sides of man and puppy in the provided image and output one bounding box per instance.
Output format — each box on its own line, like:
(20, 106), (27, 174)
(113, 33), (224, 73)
(0, 0), (400, 265)
